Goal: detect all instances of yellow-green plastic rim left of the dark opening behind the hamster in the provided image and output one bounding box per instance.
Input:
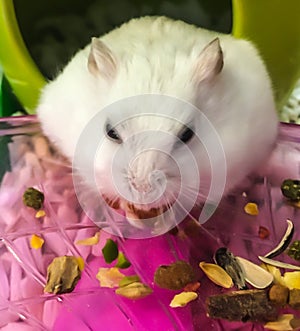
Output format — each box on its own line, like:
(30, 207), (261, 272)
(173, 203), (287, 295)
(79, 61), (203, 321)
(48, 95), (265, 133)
(0, 0), (45, 114)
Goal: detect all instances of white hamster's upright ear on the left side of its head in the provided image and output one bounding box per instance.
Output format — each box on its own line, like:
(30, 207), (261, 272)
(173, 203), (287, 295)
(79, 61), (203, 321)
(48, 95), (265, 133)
(88, 38), (117, 79)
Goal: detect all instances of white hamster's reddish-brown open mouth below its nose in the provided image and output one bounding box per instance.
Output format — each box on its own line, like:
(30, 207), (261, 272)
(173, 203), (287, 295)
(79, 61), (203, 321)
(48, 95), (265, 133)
(104, 196), (173, 220)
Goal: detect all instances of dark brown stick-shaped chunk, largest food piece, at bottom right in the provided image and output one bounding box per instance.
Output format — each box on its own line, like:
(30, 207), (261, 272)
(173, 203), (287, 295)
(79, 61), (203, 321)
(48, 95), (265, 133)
(206, 290), (278, 322)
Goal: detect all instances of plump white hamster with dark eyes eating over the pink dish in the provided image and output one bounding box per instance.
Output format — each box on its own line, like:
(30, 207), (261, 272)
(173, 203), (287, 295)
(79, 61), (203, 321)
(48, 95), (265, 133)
(37, 17), (278, 228)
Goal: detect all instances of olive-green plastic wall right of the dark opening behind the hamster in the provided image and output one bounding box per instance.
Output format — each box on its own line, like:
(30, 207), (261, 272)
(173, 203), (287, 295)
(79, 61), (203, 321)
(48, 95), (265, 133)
(232, 0), (300, 110)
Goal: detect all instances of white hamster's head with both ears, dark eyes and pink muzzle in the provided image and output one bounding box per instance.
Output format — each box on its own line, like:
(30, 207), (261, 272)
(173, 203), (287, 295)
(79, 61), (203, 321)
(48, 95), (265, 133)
(83, 39), (223, 228)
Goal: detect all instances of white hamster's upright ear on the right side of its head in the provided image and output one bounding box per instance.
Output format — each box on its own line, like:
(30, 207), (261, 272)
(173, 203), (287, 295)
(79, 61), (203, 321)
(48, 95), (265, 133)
(194, 38), (223, 83)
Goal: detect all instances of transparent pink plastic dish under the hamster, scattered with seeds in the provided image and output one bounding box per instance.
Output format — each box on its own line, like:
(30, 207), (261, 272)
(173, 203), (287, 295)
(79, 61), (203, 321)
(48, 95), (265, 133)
(0, 116), (300, 331)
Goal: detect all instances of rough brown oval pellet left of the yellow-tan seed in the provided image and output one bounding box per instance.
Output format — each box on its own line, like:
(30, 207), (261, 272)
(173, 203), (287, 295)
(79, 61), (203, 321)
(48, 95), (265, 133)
(154, 261), (195, 290)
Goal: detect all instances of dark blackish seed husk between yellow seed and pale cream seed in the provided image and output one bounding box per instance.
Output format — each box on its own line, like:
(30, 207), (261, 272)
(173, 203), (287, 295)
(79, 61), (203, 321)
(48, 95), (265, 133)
(214, 247), (246, 289)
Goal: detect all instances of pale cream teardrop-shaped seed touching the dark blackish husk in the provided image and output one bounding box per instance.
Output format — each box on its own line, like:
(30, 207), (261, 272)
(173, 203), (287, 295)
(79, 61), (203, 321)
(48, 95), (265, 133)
(236, 256), (274, 288)
